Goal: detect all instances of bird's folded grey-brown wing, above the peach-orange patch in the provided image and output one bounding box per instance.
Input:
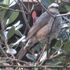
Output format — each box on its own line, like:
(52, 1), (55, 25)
(28, 12), (51, 38)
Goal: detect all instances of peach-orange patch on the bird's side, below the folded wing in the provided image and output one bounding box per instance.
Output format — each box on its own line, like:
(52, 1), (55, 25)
(36, 23), (52, 40)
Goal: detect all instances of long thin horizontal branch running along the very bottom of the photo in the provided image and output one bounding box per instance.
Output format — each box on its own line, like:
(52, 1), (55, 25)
(0, 65), (70, 69)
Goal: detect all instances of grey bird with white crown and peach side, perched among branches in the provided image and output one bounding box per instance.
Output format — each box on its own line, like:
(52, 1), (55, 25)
(18, 3), (61, 59)
